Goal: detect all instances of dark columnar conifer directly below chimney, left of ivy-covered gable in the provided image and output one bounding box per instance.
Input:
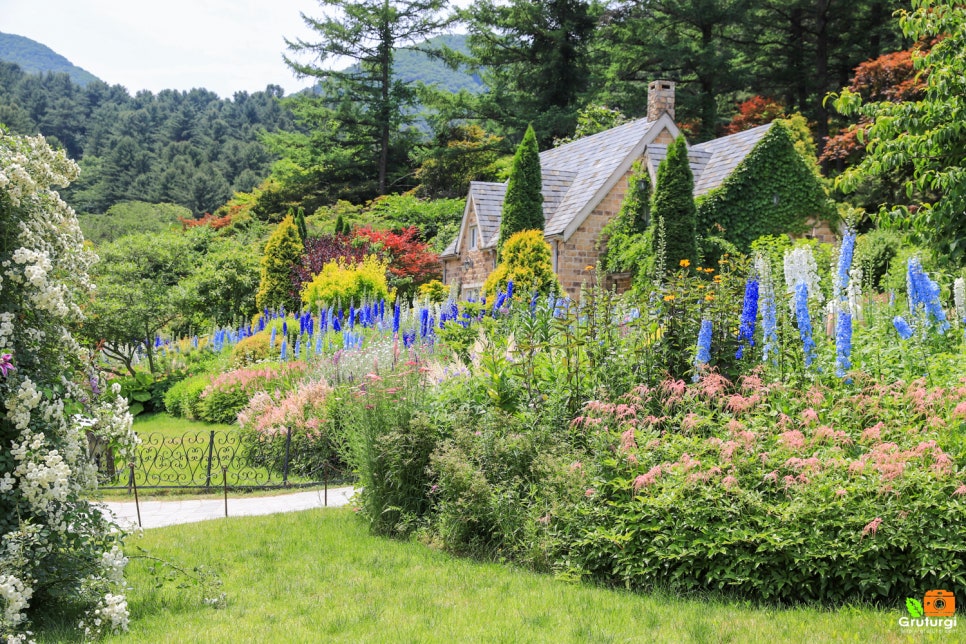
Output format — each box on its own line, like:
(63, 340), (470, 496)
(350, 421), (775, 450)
(651, 136), (698, 269)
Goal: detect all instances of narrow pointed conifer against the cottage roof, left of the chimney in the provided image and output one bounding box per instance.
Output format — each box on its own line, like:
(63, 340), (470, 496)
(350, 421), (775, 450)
(497, 126), (544, 251)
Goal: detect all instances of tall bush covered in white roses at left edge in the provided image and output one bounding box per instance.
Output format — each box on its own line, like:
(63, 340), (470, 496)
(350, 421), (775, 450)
(0, 128), (137, 644)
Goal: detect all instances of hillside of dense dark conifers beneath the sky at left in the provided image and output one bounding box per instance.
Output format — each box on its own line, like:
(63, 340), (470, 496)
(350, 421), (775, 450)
(0, 62), (293, 215)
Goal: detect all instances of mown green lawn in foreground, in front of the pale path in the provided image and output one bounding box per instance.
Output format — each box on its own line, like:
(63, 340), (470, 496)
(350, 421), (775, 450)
(38, 510), (948, 643)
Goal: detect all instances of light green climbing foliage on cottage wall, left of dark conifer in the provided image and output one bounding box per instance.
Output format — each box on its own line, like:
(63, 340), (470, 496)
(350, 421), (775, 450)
(600, 161), (653, 274)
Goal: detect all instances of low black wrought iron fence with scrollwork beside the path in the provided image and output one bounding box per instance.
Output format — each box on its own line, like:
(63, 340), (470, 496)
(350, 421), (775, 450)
(97, 430), (347, 490)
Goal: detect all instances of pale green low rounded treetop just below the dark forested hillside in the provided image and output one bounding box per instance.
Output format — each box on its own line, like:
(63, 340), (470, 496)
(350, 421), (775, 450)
(77, 201), (191, 245)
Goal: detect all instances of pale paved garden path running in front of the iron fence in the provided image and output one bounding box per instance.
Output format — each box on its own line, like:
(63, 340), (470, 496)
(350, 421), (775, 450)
(101, 487), (355, 528)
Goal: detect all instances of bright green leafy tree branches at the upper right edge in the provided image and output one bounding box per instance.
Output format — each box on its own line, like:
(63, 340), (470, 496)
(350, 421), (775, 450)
(835, 0), (966, 264)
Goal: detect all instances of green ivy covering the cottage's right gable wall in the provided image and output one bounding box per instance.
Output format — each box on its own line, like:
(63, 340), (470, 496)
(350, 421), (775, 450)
(698, 122), (835, 251)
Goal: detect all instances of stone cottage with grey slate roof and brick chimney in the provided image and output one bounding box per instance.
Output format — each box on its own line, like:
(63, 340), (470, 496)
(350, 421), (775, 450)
(440, 80), (831, 297)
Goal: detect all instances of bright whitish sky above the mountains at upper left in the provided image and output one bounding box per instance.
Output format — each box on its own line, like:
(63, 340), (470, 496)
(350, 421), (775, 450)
(0, 0), (344, 98)
